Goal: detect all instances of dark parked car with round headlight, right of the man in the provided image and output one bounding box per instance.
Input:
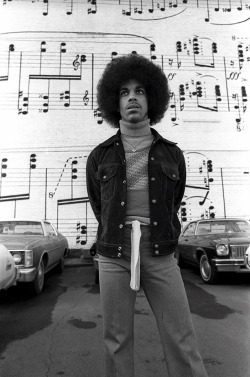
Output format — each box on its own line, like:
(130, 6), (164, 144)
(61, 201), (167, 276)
(175, 218), (250, 284)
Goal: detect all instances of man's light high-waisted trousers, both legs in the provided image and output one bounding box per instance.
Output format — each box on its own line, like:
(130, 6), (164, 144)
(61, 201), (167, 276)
(99, 226), (207, 377)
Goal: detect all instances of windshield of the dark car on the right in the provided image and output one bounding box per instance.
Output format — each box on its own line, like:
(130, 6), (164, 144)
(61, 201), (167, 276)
(196, 220), (250, 235)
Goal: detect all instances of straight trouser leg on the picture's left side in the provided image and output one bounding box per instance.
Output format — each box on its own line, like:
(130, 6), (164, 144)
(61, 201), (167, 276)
(99, 257), (136, 377)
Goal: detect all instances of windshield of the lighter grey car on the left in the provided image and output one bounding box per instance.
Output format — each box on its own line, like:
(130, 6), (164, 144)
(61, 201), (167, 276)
(0, 221), (43, 235)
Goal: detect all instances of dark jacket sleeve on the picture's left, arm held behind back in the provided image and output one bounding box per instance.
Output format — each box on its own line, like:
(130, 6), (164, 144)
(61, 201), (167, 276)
(86, 151), (101, 224)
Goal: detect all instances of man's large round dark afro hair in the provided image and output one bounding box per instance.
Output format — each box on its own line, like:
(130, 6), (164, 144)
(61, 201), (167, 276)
(97, 53), (170, 128)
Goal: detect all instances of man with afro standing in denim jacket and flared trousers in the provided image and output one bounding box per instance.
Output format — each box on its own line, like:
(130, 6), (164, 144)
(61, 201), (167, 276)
(86, 54), (207, 377)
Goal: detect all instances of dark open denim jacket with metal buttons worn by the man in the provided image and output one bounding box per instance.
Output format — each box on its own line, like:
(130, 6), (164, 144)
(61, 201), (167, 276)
(86, 128), (186, 258)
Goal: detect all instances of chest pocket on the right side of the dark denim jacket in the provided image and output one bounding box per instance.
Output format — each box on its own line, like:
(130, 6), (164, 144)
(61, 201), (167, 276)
(161, 163), (180, 199)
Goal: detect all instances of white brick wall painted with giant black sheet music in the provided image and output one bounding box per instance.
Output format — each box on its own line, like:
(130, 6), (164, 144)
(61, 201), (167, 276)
(0, 0), (250, 248)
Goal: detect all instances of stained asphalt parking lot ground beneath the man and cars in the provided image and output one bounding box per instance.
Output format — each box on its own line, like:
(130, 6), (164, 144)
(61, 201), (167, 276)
(0, 265), (250, 377)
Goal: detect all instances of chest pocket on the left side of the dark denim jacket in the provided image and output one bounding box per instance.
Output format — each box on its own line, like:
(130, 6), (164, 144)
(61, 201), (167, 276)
(96, 164), (118, 200)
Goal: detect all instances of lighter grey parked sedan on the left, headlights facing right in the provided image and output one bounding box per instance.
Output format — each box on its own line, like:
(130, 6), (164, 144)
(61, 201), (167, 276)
(0, 220), (68, 294)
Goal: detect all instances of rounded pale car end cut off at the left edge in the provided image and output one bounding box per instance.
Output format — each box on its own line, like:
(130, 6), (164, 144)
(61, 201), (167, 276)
(0, 245), (19, 290)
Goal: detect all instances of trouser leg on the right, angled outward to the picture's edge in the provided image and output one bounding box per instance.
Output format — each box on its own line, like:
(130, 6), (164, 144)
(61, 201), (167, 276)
(141, 255), (207, 377)
